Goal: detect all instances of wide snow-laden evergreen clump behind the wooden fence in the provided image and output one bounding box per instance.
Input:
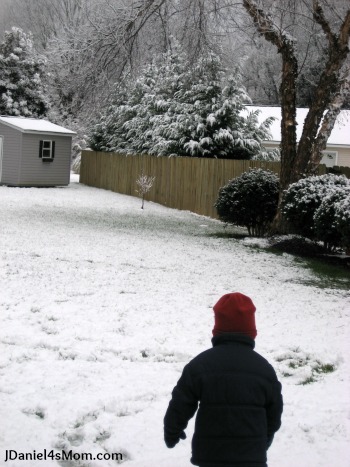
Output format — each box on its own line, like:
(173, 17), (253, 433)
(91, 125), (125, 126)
(89, 47), (272, 159)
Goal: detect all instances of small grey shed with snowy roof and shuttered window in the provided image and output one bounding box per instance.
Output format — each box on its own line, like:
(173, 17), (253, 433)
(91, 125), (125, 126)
(0, 116), (76, 186)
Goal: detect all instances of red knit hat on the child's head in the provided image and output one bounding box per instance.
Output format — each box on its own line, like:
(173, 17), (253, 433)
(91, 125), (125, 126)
(213, 292), (257, 339)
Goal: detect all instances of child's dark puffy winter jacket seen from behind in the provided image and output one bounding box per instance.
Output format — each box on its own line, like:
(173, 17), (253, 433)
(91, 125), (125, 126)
(164, 334), (283, 467)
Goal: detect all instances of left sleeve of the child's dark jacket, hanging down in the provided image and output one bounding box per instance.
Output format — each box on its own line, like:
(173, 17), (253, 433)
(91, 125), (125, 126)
(164, 365), (199, 445)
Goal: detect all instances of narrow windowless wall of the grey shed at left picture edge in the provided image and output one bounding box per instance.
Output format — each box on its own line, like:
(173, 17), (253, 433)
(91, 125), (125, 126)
(0, 123), (22, 185)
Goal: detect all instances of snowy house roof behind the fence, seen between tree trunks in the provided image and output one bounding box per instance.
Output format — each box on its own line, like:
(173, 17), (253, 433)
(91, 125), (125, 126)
(247, 105), (350, 147)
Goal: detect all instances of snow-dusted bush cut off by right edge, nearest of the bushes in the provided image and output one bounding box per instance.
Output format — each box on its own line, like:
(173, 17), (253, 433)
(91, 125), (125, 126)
(314, 184), (350, 251)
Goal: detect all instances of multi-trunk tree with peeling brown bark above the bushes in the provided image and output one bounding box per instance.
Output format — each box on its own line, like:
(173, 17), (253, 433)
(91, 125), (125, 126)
(243, 0), (350, 228)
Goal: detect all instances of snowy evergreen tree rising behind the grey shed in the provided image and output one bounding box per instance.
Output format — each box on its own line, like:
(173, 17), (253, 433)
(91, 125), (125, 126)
(0, 28), (49, 117)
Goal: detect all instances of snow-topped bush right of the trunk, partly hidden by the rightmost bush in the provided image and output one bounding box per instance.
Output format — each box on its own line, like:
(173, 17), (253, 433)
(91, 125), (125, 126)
(282, 174), (350, 239)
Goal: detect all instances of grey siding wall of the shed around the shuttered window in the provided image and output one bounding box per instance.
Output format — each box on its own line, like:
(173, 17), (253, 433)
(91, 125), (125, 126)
(18, 133), (72, 186)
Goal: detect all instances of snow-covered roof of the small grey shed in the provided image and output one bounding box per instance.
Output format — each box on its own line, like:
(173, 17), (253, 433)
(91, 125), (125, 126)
(0, 116), (76, 136)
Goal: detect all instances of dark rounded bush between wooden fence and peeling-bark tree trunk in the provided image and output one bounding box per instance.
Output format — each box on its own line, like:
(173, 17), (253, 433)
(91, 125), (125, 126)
(215, 169), (279, 236)
